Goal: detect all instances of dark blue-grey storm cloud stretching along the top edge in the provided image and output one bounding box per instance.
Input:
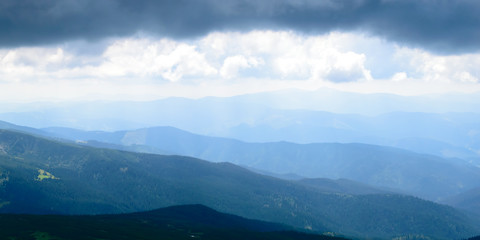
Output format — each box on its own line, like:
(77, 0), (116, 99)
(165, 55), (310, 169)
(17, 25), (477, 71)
(0, 0), (480, 53)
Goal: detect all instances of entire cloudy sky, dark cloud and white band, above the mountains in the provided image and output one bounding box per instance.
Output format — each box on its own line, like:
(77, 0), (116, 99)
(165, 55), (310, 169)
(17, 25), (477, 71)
(0, 0), (480, 102)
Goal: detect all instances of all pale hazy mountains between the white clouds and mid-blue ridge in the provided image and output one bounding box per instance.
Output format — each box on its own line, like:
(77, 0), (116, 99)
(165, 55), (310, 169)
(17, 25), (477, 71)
(0, 89), (480, 161)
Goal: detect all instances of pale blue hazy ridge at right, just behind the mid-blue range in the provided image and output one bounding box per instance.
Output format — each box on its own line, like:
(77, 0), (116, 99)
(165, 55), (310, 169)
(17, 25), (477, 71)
(223, 110), (480, 159)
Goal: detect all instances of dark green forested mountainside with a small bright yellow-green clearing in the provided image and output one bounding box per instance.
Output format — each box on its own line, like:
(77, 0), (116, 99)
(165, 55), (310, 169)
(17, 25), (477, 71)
(0, 130), (479, 239)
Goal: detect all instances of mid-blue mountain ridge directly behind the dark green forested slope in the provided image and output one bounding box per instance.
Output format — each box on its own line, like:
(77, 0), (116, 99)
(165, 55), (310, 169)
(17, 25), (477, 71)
(0, 118), (480, 216)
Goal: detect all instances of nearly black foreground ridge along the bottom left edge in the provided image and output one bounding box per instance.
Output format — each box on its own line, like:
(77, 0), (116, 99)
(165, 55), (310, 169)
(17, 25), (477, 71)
(0, 205), (343, 240)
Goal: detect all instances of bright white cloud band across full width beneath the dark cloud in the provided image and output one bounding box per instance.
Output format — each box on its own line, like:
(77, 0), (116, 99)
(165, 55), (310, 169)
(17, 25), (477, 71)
(0, 31), (480, 99)
